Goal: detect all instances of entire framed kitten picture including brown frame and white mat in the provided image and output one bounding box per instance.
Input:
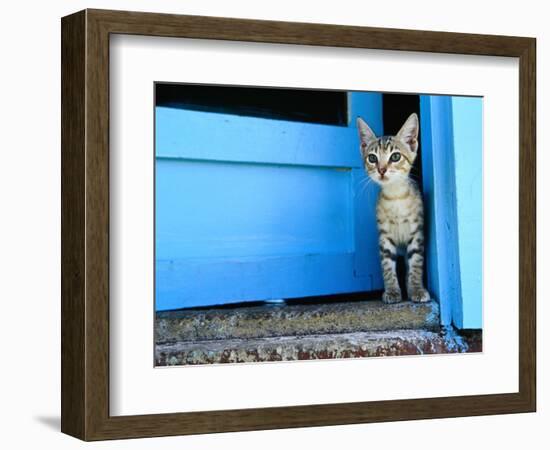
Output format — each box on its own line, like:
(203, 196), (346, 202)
(61, 9), (536, 440)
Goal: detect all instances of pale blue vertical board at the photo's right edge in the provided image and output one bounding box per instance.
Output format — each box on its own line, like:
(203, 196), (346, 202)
(451, 97), (483, 328)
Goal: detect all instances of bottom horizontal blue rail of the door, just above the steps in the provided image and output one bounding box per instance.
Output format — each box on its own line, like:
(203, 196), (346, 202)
(155, 253), (372, 311)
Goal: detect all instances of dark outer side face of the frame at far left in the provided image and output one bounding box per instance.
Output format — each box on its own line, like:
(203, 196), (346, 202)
(61, 12), (86, 439)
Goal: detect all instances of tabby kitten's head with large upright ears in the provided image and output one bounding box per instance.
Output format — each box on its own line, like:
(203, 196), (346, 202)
(357, 113), (419, 186)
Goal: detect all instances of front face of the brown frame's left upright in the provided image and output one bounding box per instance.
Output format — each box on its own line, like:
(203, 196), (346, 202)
(81, 11), (110, 440)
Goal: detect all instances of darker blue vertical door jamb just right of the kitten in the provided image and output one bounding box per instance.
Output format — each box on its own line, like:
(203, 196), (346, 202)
(420, 95), (462, 325)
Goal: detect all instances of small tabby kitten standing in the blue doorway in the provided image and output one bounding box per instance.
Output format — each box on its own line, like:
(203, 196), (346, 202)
(357, 113), (430, 303)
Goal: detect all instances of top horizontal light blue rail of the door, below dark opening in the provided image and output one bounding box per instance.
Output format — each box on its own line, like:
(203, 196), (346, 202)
(155, 107), (361, 167)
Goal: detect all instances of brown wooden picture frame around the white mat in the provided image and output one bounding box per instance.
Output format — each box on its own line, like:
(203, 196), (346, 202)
(61, 10), (536, 440)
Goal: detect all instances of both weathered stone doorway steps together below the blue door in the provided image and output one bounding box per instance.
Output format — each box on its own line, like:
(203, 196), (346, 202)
(155, 301), (481, 366)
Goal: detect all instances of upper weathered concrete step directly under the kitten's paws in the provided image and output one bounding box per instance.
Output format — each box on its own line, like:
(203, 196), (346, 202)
(155, 300), (439, 344)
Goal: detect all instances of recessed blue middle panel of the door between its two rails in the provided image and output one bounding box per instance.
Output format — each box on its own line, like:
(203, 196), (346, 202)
(156, 160), (354, 260)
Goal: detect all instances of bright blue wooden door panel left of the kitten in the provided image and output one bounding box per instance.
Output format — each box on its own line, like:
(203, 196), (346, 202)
(155, 93), (382, 310)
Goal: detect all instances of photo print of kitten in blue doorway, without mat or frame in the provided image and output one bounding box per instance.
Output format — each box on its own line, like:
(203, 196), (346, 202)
(154, 82), (483, 366)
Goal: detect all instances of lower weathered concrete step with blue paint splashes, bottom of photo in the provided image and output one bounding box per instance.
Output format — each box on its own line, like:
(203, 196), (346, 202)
(155, 330), (481, 366)
